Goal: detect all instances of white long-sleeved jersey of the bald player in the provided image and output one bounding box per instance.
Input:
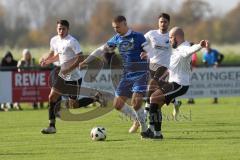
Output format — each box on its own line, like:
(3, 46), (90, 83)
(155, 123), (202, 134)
(169, 41), (202, 86)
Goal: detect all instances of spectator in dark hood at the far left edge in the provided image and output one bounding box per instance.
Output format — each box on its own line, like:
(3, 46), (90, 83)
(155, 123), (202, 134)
(0, 51), (21, 111)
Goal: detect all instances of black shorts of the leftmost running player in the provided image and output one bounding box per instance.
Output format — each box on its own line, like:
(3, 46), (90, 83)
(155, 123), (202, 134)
(52, 76), (82, 99)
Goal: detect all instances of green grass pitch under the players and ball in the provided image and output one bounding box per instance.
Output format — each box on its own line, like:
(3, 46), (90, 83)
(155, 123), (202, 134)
(0, 97), (240, 160)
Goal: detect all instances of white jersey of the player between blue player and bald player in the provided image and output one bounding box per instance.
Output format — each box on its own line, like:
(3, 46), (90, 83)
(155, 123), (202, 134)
(144, 30), (171, 68)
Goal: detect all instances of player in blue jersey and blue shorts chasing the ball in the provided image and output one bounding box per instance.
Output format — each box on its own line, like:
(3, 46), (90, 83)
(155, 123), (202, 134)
(80, 15), (151, 138)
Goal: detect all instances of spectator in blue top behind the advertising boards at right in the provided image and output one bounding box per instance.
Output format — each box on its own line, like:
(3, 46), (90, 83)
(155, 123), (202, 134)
(203, 43), (224, 104)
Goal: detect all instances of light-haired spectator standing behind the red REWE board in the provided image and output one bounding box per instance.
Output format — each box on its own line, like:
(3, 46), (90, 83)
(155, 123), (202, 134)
(17, 49), (43, 109)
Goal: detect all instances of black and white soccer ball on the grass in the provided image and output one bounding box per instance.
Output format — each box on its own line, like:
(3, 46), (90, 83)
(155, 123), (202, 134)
(90, 127), (107, 141)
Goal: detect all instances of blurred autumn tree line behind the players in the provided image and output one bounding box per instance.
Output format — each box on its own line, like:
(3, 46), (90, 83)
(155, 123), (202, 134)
(0, 0), (240, 47)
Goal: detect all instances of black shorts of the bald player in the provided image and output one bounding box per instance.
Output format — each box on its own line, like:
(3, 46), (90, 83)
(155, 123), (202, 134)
(160, 82), (189, 105)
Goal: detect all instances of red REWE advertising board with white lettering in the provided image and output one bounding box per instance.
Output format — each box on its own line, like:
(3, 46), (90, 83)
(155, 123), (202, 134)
(12, 71), (50, 102)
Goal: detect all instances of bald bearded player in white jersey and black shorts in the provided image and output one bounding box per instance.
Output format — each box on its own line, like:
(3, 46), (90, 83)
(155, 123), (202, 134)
(143, 27), (208, 139)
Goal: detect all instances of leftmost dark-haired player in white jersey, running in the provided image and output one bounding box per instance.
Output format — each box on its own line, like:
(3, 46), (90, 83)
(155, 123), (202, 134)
(40, 20), (83, 134)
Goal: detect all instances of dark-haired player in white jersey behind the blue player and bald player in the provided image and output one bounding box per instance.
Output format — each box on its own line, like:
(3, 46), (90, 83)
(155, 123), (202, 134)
(129, 13), (181, 133)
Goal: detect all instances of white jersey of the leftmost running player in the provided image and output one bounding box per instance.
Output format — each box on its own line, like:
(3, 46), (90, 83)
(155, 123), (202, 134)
(50, 35), (82, 81)
